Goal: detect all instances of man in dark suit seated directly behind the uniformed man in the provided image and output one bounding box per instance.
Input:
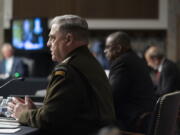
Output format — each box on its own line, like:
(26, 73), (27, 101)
(105, 32), (154, 132)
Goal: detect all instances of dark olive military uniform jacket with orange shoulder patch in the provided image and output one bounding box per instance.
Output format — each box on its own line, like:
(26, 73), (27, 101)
(19, 46), (115, 135)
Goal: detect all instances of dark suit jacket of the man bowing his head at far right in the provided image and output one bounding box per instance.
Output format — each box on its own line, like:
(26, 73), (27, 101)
(156, 59), (180, 97)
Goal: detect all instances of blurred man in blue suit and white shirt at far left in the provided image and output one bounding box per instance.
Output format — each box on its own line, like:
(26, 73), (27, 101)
(0, 43), (25, 79)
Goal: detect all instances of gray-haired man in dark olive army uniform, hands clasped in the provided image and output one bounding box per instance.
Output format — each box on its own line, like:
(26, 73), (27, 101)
(8, 15), (115, 135)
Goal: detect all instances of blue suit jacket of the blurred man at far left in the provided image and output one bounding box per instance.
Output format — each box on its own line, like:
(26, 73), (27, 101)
(0, 57), (25, 76)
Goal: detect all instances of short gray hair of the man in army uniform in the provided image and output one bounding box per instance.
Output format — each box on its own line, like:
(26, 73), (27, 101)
(50, 15), (89, 42)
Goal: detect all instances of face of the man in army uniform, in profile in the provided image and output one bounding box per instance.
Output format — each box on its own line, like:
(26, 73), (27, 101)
(47, 24), (66, 62)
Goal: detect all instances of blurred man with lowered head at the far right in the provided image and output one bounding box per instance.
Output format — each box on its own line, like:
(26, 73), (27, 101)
(145, 45), (180, 97)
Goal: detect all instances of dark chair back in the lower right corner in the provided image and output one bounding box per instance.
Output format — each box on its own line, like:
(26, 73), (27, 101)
(147, 91), (180, 135)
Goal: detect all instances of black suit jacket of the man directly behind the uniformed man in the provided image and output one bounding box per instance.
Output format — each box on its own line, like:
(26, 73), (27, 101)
(109, 50), (155, 132)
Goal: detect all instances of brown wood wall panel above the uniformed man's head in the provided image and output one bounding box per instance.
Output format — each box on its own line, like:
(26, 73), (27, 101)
(13, 0), (158, 19)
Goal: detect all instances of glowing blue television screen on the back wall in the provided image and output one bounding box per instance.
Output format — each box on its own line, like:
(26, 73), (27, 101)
(11, 17), (48, 51)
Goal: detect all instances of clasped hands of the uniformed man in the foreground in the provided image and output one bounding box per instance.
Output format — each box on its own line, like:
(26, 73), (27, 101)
(8, 96), (36, 119)
